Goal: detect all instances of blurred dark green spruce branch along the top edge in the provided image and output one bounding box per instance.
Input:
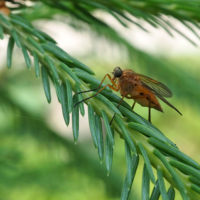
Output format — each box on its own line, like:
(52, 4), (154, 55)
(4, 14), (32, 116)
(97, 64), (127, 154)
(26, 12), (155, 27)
(9, 0), (200, 45)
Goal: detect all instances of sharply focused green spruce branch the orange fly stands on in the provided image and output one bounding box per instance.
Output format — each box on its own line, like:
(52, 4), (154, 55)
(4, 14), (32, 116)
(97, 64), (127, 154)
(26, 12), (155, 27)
(0, 1), (200, 200)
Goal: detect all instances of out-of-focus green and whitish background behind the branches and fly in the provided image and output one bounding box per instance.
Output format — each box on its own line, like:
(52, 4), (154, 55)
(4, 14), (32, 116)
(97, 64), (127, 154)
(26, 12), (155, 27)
(0, 12), (200, 200)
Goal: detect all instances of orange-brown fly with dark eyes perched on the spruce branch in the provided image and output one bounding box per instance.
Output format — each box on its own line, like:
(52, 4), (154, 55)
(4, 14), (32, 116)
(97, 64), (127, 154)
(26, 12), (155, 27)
(75, 67), (182, 124)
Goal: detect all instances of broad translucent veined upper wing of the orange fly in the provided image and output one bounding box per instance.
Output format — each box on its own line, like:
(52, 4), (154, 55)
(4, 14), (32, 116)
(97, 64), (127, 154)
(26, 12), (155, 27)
(136, 74), (172, 97)
